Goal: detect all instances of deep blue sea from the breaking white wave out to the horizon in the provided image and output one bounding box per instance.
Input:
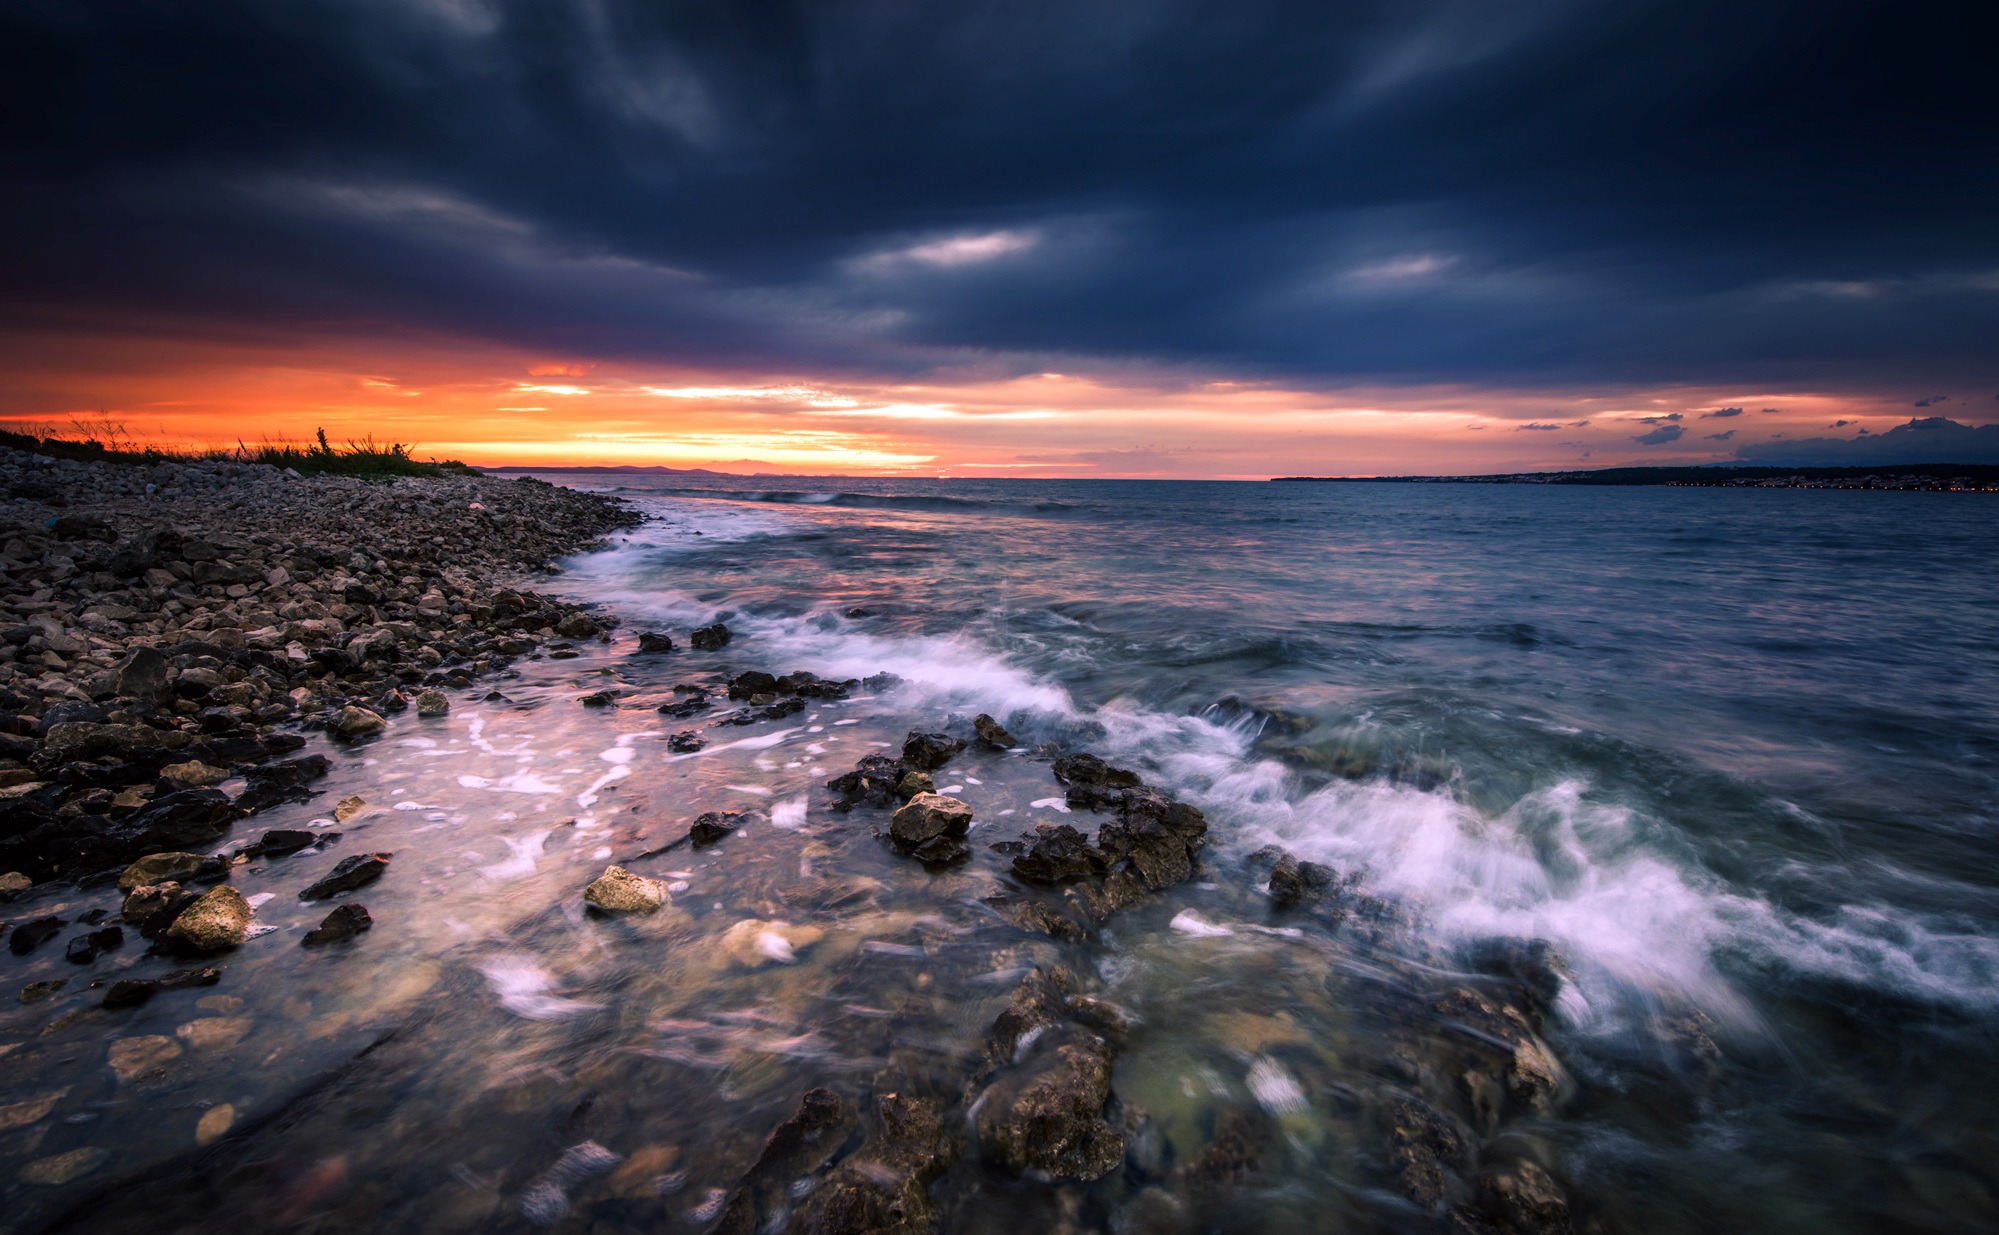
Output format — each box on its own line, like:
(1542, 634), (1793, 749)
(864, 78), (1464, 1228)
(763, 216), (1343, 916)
(543, 476), (1999, 1231)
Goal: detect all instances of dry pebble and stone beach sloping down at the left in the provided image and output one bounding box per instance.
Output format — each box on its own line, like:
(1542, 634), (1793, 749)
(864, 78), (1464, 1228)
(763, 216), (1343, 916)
(0, 441), (640, 895)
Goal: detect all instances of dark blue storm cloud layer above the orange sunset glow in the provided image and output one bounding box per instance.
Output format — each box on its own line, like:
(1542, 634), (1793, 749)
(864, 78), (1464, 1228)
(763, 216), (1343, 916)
(0, 0), (1999, 384)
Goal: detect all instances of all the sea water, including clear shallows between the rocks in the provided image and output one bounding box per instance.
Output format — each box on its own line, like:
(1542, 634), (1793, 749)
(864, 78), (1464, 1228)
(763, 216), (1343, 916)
(0, 476), (1999, 1231)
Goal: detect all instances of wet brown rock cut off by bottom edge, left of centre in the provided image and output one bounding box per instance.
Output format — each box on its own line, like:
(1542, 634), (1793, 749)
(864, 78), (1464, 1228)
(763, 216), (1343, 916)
(796, 1093), (956, 1235)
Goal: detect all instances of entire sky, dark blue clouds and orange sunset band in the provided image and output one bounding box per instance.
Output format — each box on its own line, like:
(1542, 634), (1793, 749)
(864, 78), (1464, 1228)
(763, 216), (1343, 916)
(0, 0), (1999, 478)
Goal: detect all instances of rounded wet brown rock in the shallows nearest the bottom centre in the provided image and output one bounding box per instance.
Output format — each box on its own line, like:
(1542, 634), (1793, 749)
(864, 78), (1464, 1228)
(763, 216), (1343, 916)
(974, 1039), (1123, 1181)
